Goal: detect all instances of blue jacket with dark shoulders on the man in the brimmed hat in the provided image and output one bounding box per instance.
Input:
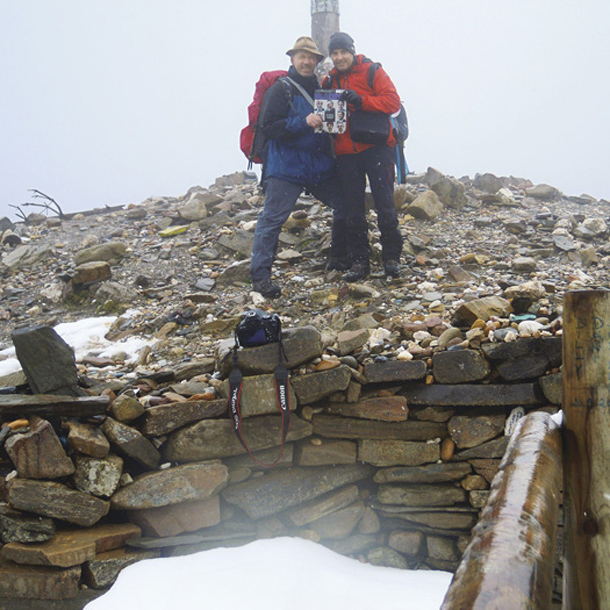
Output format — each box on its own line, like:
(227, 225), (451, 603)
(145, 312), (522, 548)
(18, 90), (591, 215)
(259, 66), (335, 186)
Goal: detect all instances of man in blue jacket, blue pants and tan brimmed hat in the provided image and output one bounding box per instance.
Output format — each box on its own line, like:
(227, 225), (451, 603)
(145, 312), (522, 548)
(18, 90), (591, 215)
(250, 36), (351, 299)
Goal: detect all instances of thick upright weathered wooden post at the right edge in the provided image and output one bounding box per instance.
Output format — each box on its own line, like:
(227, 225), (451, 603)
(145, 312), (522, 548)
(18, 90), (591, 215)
(562, 290), (610, 610)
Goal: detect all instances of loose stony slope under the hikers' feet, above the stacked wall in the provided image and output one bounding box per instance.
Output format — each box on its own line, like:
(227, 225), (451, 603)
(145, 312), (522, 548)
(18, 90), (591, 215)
(0, 164), (610, 366)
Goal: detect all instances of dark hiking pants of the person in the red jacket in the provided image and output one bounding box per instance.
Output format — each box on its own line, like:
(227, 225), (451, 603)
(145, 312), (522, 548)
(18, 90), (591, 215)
(337, 146), (402, 263)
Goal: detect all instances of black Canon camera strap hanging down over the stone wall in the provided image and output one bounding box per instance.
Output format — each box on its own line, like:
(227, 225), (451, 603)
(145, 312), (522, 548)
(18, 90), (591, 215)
(229, 334), (290, 468)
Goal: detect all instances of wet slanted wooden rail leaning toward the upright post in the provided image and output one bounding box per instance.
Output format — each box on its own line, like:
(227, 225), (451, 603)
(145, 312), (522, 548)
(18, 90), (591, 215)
(441, 411), (561, 610)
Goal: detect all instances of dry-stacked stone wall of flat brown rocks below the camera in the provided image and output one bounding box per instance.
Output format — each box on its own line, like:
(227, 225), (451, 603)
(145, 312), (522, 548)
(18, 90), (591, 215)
(0, 324), (561, 599)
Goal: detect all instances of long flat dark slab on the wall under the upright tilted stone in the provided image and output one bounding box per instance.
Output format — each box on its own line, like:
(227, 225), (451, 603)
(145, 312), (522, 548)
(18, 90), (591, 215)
(0, 394), (110, 420)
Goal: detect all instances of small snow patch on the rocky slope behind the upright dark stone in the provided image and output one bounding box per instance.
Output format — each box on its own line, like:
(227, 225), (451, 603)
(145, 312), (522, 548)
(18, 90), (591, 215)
(0, 316), (150, 376)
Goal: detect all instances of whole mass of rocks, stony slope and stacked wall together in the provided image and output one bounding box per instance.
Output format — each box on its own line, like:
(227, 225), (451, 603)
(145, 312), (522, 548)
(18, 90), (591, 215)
(0, 169), (607, 599)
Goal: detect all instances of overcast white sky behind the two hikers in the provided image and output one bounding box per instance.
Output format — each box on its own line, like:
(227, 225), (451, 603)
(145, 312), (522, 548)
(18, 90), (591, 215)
(0, 0), (610, 218)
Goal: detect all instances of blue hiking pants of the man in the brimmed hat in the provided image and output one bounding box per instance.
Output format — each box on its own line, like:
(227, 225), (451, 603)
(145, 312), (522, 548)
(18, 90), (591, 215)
(250, 176), (348, 282)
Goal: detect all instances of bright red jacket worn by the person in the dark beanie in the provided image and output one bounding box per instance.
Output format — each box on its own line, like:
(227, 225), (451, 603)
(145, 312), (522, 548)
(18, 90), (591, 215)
(322, 55), (400, 155)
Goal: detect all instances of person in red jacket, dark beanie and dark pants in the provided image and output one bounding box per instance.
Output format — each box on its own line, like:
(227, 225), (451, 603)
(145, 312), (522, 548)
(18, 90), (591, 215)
(324, 32), (402, 282)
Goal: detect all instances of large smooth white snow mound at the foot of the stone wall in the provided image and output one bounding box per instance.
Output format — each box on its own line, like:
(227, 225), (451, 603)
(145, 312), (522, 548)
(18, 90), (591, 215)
(84, 538), (453, 610)
